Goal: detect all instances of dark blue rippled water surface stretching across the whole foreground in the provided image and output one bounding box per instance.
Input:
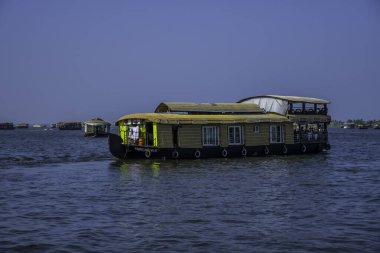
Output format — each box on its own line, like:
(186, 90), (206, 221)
(0, 129), (380, 253)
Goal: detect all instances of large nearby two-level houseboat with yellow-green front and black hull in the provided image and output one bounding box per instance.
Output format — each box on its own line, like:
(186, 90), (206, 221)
(108, 96), (331, 159)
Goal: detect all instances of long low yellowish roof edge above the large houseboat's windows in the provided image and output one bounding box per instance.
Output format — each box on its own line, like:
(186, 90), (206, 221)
(115, 113), (289, 125)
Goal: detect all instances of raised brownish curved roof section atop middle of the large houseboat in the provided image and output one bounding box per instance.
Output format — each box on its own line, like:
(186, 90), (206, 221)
(154, 102), (264, 114)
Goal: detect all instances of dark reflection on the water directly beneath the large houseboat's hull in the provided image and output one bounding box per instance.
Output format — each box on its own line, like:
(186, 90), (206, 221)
(108, 153), (329, 188)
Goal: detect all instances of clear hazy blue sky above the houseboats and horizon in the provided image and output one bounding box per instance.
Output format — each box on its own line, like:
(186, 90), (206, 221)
(0, 0), (380, 123)
